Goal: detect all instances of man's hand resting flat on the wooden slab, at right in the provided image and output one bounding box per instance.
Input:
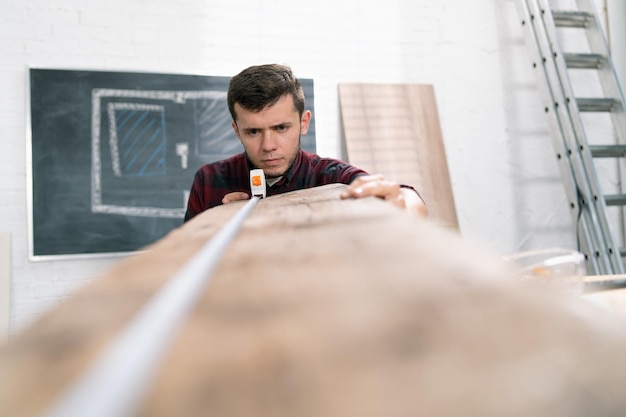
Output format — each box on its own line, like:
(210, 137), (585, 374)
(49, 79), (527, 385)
(341, 175), (428, 217)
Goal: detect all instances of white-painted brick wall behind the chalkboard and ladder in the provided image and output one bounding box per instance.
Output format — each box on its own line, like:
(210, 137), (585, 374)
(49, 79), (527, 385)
(0, 0), (612, 331)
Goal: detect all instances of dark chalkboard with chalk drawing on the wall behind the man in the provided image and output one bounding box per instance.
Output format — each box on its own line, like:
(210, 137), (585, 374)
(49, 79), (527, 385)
(29, 68), (315, 259)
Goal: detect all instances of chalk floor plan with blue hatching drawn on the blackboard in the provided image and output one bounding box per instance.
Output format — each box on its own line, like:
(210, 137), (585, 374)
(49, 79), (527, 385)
(91, 89), (230, 219)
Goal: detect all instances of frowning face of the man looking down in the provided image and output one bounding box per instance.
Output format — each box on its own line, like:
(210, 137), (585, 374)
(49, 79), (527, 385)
(232, 94), (311, 178)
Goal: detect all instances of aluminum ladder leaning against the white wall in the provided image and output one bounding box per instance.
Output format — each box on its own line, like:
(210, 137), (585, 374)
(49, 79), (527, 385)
(518, 0), (626, 275)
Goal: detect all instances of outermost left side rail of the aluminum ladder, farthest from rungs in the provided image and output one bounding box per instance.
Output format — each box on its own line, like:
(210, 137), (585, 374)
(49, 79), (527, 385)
(517, 0), (607, 274)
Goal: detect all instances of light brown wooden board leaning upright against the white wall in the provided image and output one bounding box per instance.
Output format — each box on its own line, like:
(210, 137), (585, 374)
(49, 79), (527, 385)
(339, 83), (458, 228)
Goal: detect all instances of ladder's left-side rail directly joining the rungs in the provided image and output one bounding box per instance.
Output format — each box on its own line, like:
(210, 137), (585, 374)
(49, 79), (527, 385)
(535, 0), (624, 274)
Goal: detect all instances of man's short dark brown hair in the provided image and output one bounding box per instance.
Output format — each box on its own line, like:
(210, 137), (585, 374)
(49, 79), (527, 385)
(227, 64), (304, 121)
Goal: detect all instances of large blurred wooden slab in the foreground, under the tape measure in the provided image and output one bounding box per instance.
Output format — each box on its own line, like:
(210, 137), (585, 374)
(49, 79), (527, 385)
(0, 185), (626, 417)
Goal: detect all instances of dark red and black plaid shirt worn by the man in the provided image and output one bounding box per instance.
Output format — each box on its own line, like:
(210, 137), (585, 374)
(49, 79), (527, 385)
(184, 150), (367, 221)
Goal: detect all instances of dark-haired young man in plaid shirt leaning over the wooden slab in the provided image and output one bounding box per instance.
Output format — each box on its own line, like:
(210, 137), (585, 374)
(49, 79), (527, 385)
(180, 64), (427, 221)
